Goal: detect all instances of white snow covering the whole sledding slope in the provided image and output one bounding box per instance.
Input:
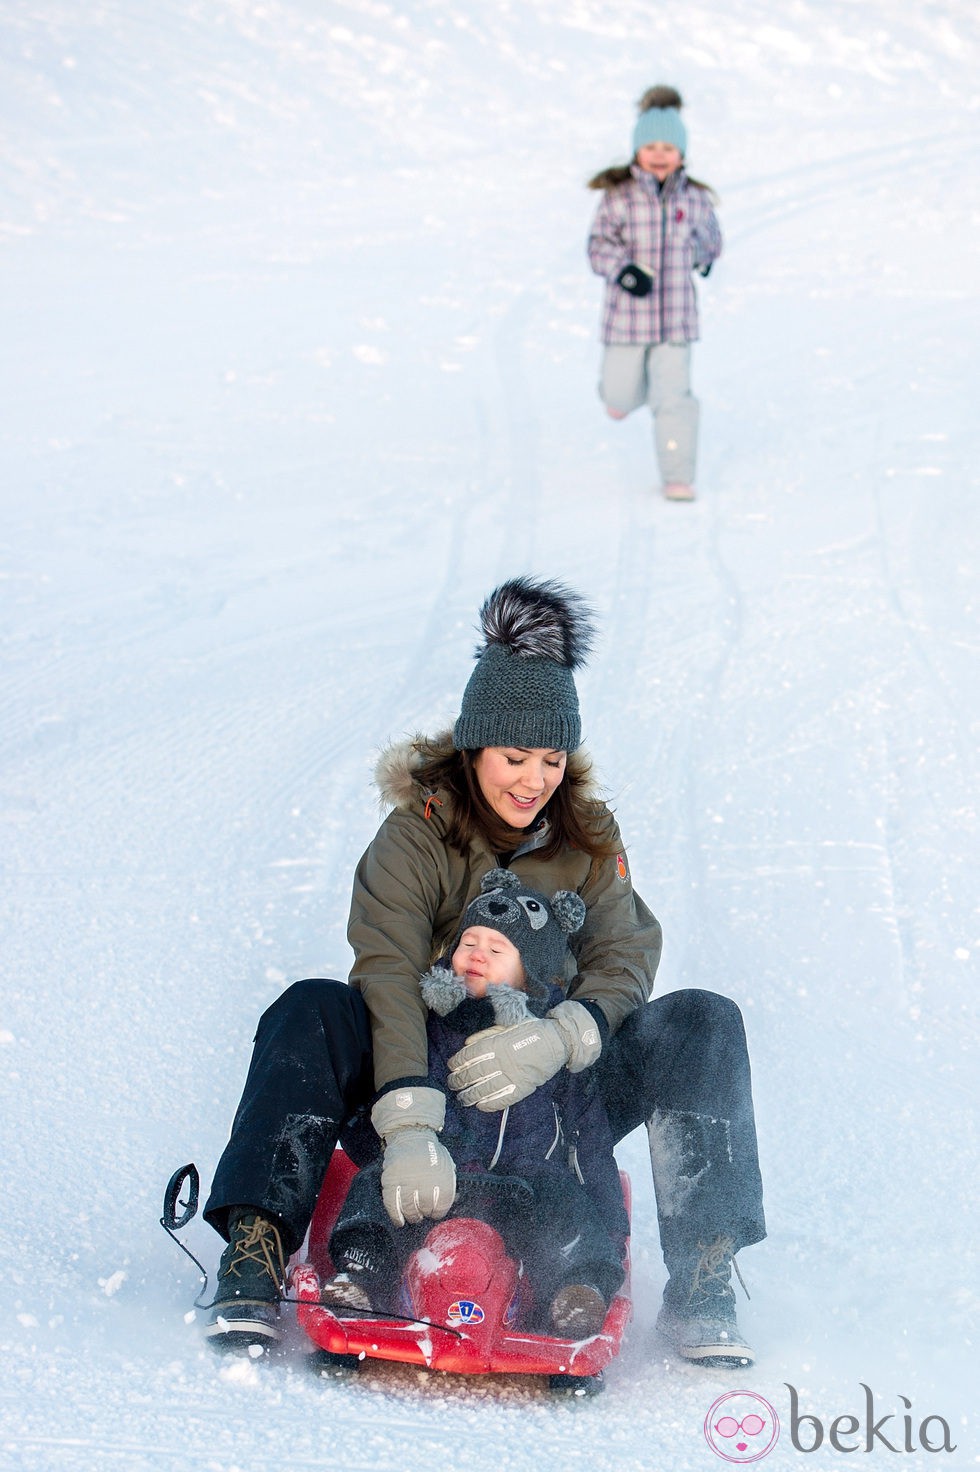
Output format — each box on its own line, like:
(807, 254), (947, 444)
(0, 0), (980, 1472)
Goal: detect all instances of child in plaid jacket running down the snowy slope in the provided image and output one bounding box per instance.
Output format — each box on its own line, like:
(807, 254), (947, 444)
(589, 87), (721, 500)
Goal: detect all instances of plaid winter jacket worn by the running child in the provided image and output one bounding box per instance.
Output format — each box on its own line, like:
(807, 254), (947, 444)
(589, 165), (721, 343)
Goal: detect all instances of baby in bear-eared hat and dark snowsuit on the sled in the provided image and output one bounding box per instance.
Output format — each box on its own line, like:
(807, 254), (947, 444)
(322, 868), (627, 1340)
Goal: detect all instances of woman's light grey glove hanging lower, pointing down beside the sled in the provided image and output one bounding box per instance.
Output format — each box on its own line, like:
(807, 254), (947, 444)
(371, 1088), (456, 1226)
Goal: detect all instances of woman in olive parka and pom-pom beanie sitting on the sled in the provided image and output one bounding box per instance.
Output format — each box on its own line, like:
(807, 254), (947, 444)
(205, 578), (765, 1363)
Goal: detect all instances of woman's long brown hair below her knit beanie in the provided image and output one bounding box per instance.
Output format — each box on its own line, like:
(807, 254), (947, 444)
(413, 737), (617, 860)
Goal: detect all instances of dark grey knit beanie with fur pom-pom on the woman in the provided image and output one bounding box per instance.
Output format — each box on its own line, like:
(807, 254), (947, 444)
(453, 577), (594, 751)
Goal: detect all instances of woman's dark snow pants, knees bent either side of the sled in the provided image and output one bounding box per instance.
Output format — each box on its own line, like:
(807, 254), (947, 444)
(205, 979), (765, 1257)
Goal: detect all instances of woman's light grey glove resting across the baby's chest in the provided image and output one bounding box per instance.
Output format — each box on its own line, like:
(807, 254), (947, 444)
(449, 1002), (602, 1111)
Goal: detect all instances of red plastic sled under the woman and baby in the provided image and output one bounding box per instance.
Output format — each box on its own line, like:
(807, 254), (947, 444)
(291, 1148), (633, 1394)
